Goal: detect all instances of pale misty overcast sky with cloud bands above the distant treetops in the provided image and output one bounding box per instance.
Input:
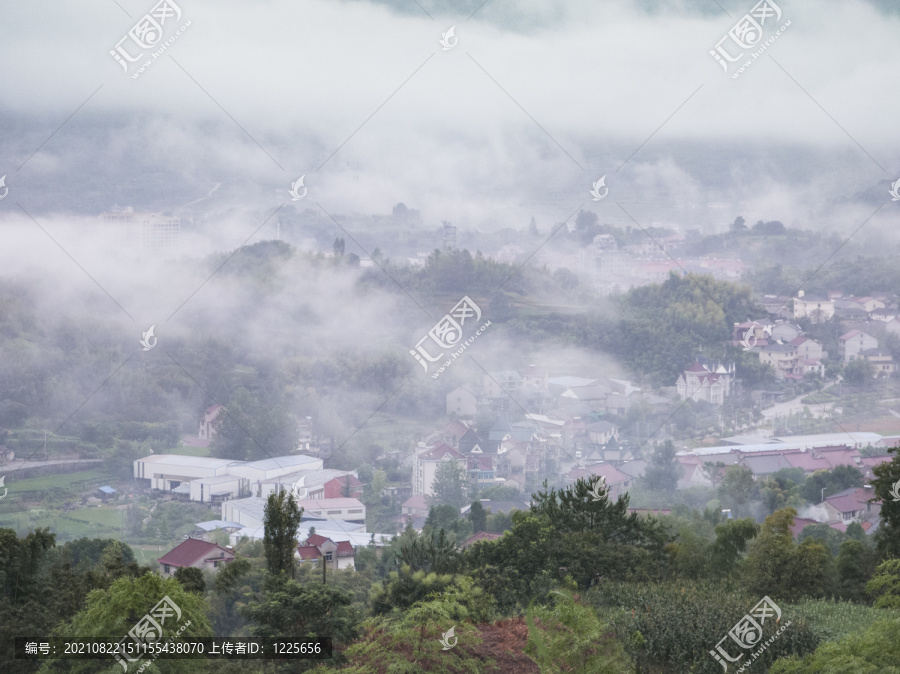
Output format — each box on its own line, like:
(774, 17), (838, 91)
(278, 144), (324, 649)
(0, 0), (900, 234)
